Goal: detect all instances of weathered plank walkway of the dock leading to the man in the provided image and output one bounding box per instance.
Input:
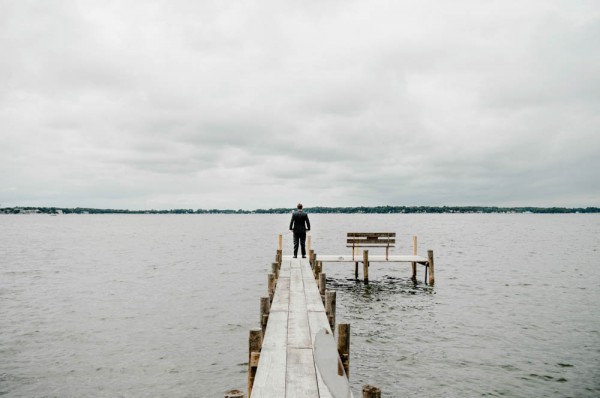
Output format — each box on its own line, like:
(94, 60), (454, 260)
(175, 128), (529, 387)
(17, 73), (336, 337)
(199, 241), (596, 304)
(249, 256), (352, 398)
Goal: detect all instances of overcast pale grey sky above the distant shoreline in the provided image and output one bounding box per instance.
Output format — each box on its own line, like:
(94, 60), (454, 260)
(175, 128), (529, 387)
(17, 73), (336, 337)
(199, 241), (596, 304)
(0, 0), (600, 209)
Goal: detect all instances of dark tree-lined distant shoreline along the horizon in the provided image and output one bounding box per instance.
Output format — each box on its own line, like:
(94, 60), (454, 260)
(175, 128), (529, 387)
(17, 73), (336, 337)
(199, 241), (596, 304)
(0, 206), (600, 214)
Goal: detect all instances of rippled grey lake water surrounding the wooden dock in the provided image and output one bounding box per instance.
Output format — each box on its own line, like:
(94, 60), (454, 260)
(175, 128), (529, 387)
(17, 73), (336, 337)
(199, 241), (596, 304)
(0, 214), (600, 397)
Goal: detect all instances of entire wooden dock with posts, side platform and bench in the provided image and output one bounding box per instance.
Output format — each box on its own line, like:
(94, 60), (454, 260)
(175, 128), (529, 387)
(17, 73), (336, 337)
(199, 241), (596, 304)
(225, 232), (434, 398)
